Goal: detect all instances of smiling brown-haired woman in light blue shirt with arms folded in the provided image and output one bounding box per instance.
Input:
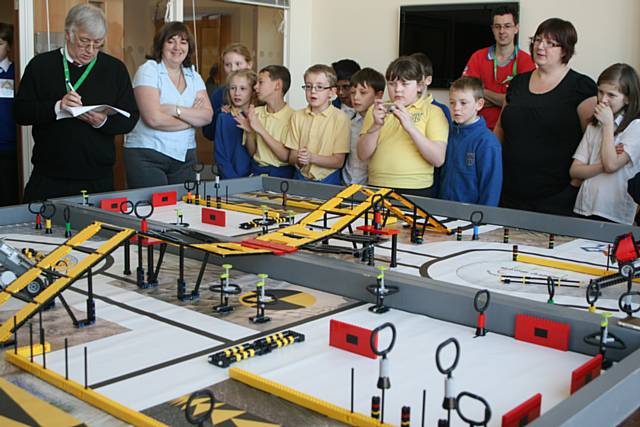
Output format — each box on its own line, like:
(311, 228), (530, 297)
(124, 22), (213, 188)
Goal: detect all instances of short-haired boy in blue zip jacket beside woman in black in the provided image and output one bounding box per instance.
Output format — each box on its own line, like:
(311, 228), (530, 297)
(440, 77), (502, 206)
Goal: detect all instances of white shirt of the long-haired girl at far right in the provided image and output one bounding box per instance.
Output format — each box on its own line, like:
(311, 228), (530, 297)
(573, 115), (640, 224)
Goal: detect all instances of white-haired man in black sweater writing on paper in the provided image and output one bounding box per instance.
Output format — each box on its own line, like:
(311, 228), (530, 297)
(15, 4), (139, 202)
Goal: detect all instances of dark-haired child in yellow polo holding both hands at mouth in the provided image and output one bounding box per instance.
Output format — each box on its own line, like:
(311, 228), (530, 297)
(358, 57), (449, 197)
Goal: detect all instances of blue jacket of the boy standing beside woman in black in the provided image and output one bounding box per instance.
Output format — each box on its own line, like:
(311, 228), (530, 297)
(440, 117), (502, 206)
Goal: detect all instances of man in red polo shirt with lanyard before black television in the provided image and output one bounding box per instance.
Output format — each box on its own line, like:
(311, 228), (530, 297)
(462, 6), (536, 129)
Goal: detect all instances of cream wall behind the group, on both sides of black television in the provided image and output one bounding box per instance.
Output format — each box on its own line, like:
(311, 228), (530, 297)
(290, 0), (640, 107)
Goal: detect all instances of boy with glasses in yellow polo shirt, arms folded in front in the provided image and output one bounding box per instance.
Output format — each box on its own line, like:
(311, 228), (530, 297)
(285, 64), (350, 185)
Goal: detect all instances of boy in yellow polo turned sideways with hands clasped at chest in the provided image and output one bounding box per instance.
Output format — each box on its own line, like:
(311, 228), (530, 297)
(237, 65), (294, 178)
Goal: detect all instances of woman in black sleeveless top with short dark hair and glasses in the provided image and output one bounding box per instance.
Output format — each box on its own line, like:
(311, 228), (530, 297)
(495, 18), (597, 215)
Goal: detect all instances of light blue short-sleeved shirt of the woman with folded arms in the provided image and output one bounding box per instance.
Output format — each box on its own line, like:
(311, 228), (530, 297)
(124, 59), (206, 162)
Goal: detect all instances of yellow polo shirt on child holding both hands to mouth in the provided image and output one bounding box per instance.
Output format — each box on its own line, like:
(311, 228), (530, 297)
(360, 96), (449, 189)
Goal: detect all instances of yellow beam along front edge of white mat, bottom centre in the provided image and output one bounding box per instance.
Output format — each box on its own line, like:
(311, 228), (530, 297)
(229, 367), (391, 427)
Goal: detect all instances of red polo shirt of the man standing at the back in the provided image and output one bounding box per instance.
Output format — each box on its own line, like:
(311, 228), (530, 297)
(462, 45), (536, 129)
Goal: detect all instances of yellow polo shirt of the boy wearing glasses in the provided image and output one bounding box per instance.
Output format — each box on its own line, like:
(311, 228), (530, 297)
(284, 105), (351, 181)
